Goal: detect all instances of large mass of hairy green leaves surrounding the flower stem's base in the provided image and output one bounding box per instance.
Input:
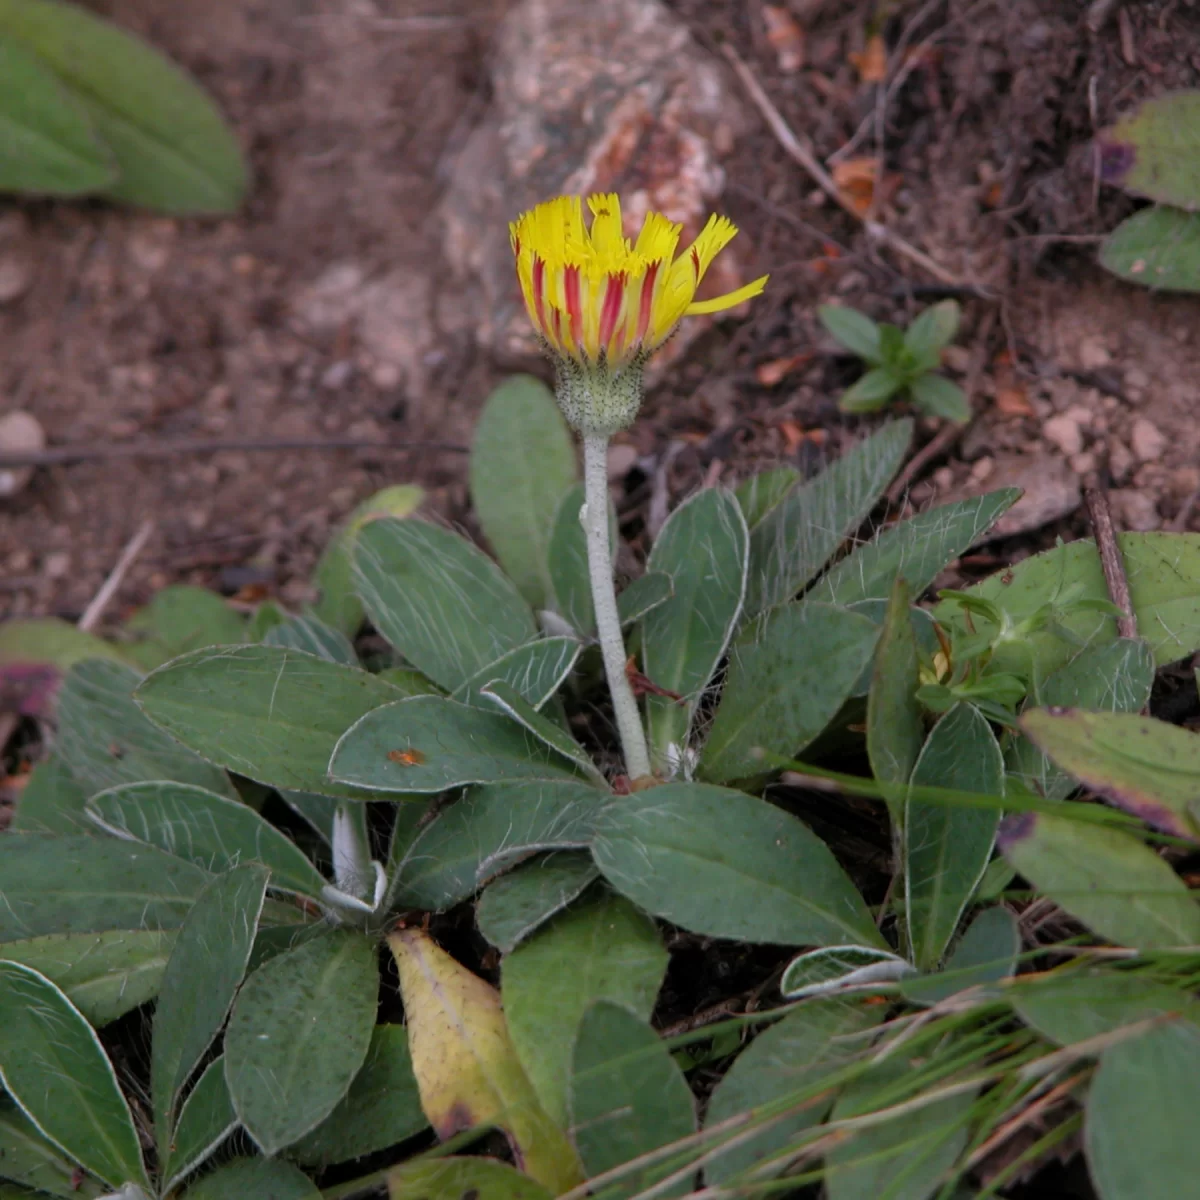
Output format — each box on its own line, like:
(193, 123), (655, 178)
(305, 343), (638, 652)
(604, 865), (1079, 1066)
(7, 369), (1200, 1200)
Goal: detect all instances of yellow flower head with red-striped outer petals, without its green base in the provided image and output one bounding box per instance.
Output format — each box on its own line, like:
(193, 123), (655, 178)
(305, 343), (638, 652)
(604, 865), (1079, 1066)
(509, 194), (767, 372)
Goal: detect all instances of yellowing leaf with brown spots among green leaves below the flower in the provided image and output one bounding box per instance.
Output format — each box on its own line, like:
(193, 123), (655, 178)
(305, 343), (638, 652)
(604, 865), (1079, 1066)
(388, 929), (583, 1195)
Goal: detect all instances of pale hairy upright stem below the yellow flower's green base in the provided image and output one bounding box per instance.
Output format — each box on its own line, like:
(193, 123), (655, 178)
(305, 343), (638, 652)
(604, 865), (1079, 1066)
(580, 433), (650, 779)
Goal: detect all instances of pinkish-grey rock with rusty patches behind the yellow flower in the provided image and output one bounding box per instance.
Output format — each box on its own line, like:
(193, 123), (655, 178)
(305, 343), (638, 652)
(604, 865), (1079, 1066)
(442, 0), (744, 368)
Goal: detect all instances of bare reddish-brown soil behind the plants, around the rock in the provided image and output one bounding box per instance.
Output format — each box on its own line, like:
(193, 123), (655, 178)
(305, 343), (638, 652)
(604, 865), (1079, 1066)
(0, 0), (1200, 618)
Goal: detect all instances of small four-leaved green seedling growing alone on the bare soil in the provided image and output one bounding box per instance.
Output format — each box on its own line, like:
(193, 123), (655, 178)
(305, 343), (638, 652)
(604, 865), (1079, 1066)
(817, 300), (971, 422)
